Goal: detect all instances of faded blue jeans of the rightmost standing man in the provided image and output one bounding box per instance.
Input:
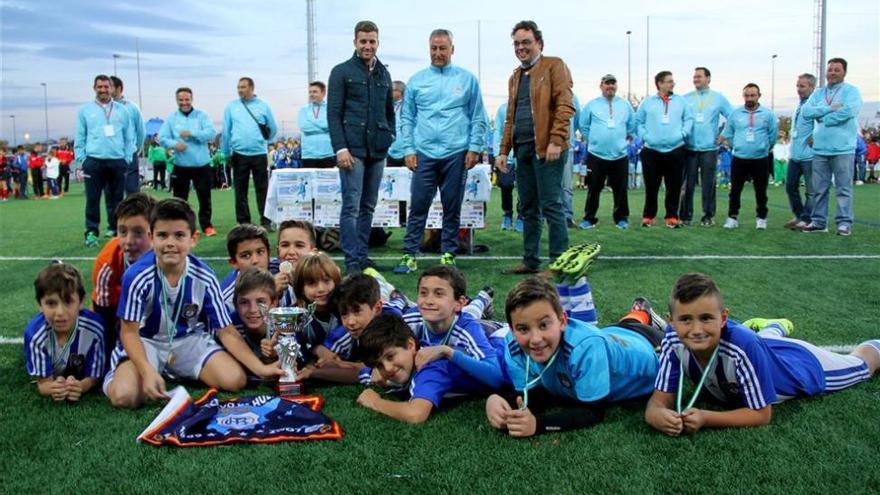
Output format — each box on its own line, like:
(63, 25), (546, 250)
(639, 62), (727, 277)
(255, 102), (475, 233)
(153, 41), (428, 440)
(811, 153), (855, 228)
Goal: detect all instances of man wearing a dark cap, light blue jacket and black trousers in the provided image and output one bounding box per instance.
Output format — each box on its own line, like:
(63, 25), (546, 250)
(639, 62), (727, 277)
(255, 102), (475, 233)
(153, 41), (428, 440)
(580, 74), (636, 229)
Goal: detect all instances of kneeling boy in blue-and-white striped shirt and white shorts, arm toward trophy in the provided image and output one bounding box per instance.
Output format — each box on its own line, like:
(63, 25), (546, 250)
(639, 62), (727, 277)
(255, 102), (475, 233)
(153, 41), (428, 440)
(104, 198), (284, 408)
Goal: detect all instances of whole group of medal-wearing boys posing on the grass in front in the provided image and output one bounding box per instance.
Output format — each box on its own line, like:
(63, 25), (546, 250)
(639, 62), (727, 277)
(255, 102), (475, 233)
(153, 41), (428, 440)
(18, 193), (880, 437)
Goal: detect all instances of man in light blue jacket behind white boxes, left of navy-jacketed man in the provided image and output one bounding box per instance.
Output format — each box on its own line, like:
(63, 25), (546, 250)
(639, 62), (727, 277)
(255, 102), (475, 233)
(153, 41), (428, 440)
(298, 81), (336, 168)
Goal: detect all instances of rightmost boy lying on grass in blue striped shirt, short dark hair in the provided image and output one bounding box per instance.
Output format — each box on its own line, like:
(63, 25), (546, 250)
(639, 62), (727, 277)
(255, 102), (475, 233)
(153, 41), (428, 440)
(645, 273), (880, 436)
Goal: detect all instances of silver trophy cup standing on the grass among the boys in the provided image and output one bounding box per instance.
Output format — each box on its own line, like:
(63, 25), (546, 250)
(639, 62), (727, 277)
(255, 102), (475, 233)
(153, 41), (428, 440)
(266, 304), (315, 395)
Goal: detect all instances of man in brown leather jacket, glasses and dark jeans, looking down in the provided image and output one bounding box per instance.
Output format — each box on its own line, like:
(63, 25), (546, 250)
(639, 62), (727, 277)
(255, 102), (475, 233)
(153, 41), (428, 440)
(495, 21), (575, 274)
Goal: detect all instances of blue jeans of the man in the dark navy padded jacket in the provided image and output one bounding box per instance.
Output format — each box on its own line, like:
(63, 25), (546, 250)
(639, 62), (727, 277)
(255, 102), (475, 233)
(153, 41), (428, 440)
(339, 157), (385, 270)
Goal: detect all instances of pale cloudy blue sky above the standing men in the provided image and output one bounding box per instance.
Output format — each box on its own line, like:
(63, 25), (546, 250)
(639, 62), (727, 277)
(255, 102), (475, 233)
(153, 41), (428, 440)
(0, 0), (880, 143)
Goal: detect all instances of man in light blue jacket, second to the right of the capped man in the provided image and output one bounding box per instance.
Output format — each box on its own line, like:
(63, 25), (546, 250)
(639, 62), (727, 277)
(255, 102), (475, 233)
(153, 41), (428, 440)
(679, 67), (733, 227)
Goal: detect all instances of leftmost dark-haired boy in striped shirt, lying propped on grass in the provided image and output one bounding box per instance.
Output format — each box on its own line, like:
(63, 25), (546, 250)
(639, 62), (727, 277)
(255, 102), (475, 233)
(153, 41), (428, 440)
(24, 263), (104, 402)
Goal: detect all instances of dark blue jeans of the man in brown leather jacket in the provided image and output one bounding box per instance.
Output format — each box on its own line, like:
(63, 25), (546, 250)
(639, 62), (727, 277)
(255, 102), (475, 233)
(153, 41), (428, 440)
(516, 143), (568, 268)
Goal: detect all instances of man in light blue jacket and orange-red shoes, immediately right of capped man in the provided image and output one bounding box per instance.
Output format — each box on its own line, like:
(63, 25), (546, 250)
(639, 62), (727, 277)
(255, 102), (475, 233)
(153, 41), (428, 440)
(636, 70), (694, 229)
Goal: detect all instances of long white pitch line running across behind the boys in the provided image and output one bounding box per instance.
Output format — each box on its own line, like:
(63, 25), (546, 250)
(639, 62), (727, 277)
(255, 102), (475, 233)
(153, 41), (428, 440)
(0, 254), (880, 262)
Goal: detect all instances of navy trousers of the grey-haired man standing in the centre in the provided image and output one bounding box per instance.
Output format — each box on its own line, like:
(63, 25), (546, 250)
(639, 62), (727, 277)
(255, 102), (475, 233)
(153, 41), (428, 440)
(403, 152), (467, 256)
